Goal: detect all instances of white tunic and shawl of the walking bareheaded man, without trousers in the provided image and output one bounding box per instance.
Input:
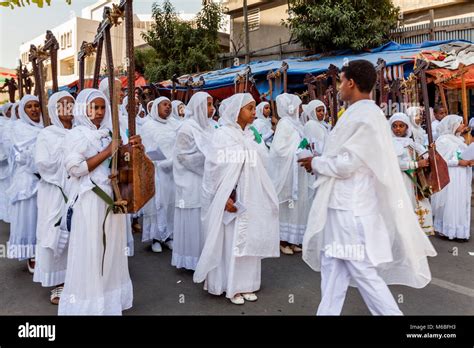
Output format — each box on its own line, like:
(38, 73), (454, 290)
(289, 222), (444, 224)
(303, 100), (436, 288)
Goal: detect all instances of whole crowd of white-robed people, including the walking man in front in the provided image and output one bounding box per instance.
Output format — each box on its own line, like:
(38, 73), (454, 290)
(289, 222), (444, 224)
(0, 60), (466, 315)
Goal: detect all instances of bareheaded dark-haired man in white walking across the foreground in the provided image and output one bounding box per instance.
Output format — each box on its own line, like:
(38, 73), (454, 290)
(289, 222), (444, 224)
(300, 60), (436, 315)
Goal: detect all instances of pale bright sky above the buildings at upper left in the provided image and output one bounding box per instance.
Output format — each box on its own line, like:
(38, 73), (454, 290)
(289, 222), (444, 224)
(0, 0), (201, 69)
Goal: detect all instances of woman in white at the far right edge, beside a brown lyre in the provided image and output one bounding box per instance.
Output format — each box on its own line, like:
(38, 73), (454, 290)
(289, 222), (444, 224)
(432, 115), (474, 241)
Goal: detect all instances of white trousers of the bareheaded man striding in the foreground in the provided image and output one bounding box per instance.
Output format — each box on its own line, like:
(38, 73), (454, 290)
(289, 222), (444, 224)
(317, 253), (403, 315)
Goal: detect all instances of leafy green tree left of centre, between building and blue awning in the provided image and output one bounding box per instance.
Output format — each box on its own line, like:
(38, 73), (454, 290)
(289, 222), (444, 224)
(135, 0), (223, 81)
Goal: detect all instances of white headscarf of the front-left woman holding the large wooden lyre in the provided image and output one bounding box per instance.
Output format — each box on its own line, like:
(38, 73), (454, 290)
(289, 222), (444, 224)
(73, 88), (112, 131)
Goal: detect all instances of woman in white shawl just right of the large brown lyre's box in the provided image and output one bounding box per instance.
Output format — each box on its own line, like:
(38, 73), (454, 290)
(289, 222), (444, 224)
(142, 97), (176, 252)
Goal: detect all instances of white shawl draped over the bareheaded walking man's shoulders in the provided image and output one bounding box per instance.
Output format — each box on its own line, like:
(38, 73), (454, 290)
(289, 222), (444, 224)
(303, 100), (436, 288)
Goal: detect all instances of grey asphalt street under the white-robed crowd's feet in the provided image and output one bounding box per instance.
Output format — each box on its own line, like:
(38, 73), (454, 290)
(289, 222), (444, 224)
(0, 216), (474, 315)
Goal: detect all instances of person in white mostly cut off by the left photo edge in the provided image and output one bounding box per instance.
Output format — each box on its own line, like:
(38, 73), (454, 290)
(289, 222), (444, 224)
(0, 103), (13, 222)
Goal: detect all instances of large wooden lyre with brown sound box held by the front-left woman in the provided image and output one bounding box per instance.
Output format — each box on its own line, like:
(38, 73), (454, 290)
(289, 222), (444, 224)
(84, 0), (155, 213)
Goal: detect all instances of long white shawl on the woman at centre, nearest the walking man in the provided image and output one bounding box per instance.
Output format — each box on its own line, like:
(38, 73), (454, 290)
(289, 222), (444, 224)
(193, 94), (280, 283)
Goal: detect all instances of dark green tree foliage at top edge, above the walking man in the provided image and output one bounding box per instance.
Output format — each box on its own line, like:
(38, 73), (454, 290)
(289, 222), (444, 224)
(284, 0), (400, 52)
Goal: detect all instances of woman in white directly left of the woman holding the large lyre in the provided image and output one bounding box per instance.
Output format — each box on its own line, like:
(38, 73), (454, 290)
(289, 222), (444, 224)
(33, 92), (74, 305)
